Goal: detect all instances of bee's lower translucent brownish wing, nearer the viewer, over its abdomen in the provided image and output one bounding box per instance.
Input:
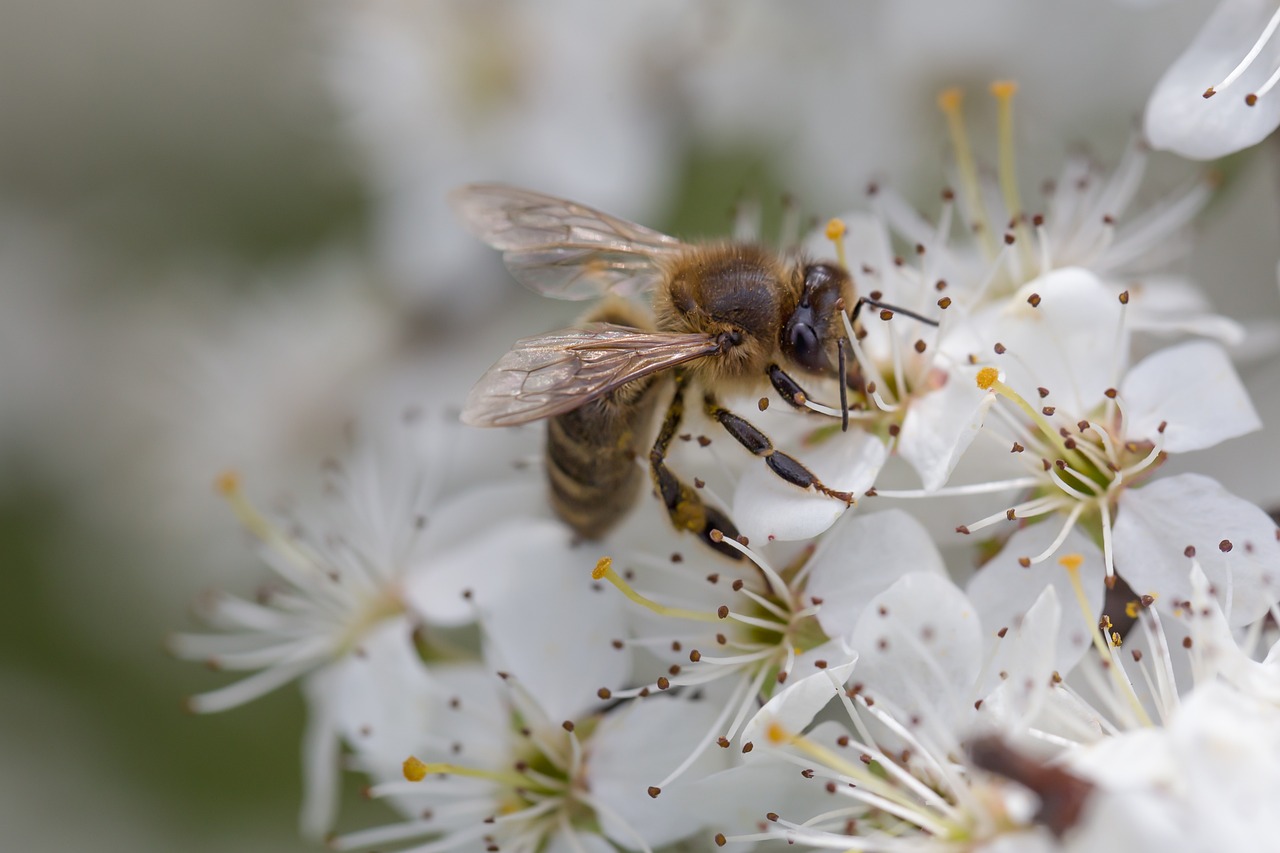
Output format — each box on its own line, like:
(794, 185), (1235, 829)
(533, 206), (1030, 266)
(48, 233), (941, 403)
(462, 323), (719, 427)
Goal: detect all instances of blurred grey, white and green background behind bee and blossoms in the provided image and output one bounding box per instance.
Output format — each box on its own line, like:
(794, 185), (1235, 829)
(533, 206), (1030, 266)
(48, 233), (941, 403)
(0, 0), (1280, 853)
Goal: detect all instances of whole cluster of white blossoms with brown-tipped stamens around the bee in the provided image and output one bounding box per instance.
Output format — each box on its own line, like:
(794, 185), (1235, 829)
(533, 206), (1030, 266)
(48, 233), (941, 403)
(173, 83), (1280, 853)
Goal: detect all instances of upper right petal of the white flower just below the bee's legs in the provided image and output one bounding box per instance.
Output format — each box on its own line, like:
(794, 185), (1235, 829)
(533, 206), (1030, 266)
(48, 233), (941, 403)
(805, 510), (946, 638)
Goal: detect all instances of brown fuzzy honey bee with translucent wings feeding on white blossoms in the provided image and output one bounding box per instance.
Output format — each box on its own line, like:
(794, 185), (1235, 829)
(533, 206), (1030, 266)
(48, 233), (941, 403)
(451, 183), (916, 557)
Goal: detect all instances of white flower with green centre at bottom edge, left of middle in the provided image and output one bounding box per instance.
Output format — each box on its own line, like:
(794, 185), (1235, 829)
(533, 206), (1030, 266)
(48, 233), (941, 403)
(330, 666), (723, 853)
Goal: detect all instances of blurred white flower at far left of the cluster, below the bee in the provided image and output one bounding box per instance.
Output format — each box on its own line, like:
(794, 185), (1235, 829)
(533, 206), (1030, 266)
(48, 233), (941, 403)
(170, 415), (552, 836)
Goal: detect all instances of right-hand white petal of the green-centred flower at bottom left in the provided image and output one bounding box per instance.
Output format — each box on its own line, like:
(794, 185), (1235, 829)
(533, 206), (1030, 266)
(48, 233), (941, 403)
(590, 695), (730, 849)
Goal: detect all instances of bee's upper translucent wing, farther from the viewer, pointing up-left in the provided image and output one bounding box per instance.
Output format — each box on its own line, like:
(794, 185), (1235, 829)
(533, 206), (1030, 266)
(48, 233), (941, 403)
(449, 183), (684, 300)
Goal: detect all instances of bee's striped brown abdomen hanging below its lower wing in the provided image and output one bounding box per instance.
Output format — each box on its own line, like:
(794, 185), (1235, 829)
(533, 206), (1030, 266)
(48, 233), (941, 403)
(547, 377), (655, 539)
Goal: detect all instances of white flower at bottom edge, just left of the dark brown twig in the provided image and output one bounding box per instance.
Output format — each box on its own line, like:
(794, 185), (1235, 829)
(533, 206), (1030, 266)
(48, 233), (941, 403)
(730, 574), (1060, 850)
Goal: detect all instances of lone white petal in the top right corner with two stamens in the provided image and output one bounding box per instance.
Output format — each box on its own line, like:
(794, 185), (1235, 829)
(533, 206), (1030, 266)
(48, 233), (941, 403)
(1144, 0), (1280, 160)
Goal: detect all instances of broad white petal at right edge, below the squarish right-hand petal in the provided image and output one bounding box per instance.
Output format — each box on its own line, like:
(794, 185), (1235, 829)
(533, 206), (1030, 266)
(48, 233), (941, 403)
(1114, 474), (1280, 626)
